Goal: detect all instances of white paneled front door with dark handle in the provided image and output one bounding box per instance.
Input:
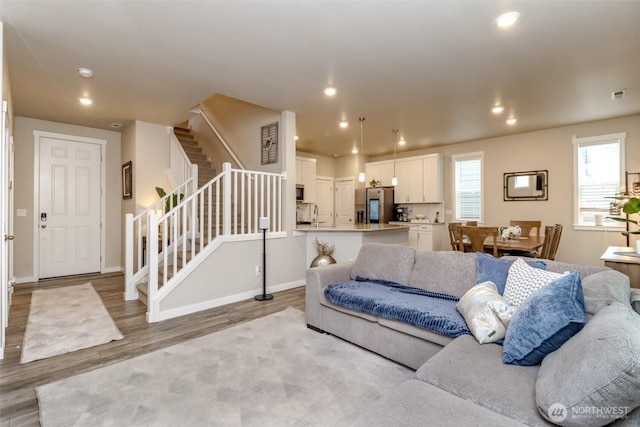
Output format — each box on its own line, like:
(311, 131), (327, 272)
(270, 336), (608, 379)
(35, 136), (102, 279)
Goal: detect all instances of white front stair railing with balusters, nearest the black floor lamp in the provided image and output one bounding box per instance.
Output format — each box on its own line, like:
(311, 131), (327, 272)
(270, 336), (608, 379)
(147, 163), (285, 322)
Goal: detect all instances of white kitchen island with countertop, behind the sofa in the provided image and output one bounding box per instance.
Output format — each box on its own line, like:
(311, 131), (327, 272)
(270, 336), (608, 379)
(294, 224), (409, 266)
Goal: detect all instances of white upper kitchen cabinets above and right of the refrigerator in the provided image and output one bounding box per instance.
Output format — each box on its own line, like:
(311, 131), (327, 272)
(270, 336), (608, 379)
(365, 154), (444, 204)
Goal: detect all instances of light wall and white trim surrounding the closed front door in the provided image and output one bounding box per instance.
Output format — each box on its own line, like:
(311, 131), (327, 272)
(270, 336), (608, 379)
(14, 116), (122, 282)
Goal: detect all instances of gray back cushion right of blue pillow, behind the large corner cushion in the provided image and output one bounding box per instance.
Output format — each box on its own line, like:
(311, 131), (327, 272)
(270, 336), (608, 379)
(582, 270), (630, 319)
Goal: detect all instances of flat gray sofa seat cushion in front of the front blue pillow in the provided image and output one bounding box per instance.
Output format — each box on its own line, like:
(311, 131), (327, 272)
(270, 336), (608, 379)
(416, 335), (550, 426)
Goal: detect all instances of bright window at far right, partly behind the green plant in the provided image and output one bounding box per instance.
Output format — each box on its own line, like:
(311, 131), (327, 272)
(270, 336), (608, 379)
(573, 133), (627, 226)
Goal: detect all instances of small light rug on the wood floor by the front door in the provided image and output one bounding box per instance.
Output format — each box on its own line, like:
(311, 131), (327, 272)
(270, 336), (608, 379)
(20, 283), (124, 363)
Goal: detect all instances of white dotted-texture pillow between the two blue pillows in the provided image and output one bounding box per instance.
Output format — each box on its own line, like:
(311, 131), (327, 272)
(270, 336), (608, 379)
(503, 258), (562, 307)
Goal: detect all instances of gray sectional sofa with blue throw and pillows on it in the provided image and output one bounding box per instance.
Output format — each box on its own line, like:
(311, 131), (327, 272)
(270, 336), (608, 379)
(306, 244), (640, 427)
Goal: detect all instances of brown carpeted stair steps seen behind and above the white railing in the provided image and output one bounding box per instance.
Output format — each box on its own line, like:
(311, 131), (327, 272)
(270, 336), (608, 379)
(136, 127), (217, 304)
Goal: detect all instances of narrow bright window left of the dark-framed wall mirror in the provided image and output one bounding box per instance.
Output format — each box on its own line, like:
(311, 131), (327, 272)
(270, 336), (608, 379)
(451, 153), (484, 222)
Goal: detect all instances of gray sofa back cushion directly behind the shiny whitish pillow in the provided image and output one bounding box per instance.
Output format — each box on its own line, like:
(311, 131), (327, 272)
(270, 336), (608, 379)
(409, 251), (476, 298)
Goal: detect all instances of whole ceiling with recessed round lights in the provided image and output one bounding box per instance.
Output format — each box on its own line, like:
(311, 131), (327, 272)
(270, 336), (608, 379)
(0, 0), (640, 156)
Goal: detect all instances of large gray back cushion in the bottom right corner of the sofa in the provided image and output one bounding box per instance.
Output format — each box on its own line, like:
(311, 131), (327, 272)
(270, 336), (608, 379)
(536, 302), (640, 426)
